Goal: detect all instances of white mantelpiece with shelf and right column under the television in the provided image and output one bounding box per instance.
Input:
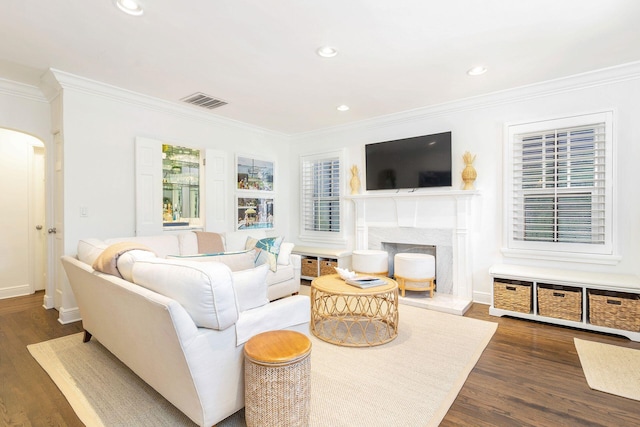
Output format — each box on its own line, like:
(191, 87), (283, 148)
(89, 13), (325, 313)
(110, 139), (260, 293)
(345, 189), (480, 314)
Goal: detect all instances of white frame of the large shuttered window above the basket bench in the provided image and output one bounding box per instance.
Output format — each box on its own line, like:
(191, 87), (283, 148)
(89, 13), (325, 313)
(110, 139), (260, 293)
(503, 111), (615, 263)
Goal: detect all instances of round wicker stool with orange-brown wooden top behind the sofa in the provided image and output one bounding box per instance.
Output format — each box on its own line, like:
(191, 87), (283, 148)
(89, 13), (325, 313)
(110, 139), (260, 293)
(244, 330), (311, 427)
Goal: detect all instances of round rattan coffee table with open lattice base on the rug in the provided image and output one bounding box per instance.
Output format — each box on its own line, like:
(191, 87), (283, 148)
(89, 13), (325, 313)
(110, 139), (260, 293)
(311, 274), (398, 347)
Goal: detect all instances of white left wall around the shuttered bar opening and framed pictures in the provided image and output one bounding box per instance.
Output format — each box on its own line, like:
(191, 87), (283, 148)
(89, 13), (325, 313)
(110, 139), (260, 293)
(57, 78), (290, 253)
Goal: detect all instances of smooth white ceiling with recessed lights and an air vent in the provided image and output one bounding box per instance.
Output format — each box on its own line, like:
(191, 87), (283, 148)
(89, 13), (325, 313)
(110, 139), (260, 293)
(0, 0), (640, 134)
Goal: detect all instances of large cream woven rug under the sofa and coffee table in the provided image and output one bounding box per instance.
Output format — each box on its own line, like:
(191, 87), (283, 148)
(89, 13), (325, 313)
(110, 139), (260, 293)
(28, 305), (497, 427)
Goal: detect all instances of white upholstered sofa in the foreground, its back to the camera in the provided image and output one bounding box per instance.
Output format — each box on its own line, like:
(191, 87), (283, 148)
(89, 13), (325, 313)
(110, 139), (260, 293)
(62, 235), (310, 426)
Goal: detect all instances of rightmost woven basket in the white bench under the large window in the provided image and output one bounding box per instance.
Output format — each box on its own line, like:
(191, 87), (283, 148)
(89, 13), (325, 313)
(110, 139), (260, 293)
(589, 290), (640, 332)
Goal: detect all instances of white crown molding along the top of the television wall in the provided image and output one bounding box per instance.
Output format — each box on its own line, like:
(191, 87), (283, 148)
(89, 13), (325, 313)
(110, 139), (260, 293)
(293, 61), (640, 141)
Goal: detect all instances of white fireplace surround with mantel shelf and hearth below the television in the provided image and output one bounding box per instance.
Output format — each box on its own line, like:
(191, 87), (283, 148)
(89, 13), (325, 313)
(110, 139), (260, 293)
(347, 190), (478, 315)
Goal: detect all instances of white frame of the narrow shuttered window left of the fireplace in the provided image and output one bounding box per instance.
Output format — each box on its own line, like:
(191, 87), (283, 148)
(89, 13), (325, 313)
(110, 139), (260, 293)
(299, 150), (345, 243)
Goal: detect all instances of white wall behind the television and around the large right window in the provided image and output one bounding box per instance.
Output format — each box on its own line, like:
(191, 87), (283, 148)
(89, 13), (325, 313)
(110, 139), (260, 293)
(291, 63), (640, 302)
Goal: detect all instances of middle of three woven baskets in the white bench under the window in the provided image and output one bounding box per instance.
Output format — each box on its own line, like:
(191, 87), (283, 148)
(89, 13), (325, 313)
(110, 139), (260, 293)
(538, 284), (582, 322)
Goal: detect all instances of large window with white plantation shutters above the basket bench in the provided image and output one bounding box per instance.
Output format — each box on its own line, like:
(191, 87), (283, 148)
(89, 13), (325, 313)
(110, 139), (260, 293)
(506, 113), (612, 260)
